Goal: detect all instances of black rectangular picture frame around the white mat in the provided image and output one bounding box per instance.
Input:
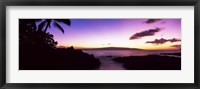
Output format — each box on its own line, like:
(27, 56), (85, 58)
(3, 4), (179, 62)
(0, 0), (200, 89)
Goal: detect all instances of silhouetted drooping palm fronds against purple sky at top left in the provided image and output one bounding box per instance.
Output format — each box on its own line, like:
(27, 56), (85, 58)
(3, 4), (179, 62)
(38, 19), (71, 33)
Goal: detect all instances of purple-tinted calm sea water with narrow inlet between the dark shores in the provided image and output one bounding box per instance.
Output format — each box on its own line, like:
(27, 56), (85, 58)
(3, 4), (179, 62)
(83, 50), (179, 70)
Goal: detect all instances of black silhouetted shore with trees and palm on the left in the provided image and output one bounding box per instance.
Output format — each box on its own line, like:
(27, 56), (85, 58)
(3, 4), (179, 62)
(19, 19), (100, 70)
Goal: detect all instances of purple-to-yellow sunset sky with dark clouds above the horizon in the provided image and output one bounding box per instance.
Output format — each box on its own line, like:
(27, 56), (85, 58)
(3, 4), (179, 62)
(40, 18), (181, 50)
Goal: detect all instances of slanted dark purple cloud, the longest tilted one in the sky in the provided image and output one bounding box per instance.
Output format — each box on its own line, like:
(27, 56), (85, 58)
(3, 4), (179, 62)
(130, 27), (161, 40)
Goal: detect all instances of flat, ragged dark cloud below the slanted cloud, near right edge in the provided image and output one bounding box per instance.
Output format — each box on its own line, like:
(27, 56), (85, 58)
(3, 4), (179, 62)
(146, 38), (181, 45)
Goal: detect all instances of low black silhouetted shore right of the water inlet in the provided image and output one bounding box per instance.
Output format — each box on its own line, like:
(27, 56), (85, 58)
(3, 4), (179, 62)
(113, 55), (181, 70)
